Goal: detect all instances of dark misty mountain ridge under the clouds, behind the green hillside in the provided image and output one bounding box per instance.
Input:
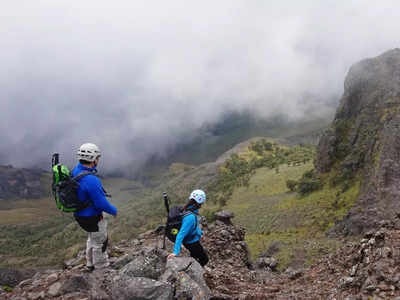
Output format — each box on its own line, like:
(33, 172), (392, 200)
(133, 107), (334, 183)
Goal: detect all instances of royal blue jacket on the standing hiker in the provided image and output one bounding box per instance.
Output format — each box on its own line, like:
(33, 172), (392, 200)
(72, 163), (117, 217)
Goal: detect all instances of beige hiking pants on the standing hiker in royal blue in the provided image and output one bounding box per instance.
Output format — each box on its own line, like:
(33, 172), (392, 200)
(86, 219), (109, 269)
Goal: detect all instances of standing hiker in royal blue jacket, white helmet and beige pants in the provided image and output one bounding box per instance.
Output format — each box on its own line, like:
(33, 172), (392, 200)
(72, 143), (117, 271)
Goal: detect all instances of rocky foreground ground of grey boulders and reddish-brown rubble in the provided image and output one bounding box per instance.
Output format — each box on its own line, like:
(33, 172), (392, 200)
(0, 212), (400, 300)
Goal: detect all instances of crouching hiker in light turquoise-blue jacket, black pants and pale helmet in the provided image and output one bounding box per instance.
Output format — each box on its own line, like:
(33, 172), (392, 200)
(168, 190), (208, 267)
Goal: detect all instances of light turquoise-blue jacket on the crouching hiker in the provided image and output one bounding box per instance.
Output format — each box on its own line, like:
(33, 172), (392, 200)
(174, 210), (203, 255)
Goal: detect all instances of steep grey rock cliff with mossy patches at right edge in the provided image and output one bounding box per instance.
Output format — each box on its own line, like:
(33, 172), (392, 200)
(315, 49), (400, 234)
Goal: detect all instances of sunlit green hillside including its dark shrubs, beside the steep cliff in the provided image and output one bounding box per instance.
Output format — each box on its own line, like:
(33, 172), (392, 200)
(207, 140), (359, 270)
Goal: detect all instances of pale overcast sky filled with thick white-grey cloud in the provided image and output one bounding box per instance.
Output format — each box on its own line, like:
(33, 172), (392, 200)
(0, 0), (400, 168)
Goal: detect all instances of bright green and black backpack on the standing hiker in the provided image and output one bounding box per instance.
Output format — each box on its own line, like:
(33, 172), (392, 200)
(52, 164), (94, 212)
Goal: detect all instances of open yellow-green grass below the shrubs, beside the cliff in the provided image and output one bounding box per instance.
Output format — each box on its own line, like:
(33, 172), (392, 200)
(212, 144), (359, 269)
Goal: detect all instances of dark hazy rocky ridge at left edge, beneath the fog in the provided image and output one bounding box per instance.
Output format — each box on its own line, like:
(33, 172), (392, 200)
(0, 166), (45, 201)
